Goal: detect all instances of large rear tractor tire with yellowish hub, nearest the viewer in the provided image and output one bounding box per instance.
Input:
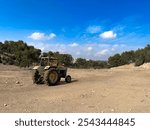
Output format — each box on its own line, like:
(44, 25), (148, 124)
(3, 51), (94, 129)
(44, 69), (59, 86)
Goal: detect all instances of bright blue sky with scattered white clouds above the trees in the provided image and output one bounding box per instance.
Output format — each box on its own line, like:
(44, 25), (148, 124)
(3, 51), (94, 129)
(0, 0), (150, 60)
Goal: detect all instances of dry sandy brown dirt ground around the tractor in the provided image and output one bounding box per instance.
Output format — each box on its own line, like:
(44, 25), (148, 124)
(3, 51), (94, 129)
(0, 65), (150, 113)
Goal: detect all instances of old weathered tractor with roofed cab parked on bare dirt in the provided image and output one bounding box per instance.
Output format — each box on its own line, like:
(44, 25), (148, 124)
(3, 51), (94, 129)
(33, 57), (71, 86)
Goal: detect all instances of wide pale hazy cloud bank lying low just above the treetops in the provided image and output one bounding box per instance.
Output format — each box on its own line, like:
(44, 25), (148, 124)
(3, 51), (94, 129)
(30, 42), (139, 60)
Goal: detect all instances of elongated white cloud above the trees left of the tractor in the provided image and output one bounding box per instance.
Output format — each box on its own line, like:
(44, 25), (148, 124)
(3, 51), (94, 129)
(28, 32), (56, 40)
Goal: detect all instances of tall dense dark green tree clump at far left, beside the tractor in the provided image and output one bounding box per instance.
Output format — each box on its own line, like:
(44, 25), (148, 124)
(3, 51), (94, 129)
(0, 41), (41, 67)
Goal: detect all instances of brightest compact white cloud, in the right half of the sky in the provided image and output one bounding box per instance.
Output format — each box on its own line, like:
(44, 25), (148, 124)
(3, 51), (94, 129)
(99, 31), (117, 39)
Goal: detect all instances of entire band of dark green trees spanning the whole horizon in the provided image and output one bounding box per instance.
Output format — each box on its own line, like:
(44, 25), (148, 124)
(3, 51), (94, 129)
(0, 40), (150, 69)
